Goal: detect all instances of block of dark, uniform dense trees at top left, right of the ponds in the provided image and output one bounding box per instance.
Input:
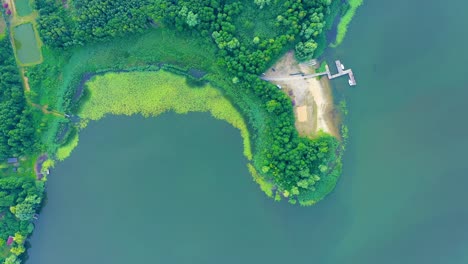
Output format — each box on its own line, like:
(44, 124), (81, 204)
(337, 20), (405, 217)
(34, 0), (150, 47)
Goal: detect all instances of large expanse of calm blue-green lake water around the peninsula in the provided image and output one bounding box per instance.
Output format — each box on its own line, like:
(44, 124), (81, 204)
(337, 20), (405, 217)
(27, 0), (468, 264)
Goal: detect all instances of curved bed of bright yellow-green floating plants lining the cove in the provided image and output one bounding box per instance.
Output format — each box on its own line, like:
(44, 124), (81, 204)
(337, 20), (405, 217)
(79, 70), (252, 160)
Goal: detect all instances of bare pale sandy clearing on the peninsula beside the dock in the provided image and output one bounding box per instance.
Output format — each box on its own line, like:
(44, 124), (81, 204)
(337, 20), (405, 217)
(263, 52), (339, 137)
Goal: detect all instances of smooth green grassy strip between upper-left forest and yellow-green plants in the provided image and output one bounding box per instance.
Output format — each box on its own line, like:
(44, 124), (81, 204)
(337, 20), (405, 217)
(27, 29), (219, 112)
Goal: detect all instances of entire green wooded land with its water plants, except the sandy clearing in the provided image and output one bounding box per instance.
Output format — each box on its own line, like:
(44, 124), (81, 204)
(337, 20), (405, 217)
(0, 0), (362, 263)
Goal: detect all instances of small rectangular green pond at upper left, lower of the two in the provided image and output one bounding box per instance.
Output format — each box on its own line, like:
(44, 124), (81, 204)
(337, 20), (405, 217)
(14, 23), (41, 64)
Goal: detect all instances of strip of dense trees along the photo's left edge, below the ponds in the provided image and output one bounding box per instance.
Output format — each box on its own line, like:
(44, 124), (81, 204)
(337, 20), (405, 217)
(0, 19), (44, 263)
